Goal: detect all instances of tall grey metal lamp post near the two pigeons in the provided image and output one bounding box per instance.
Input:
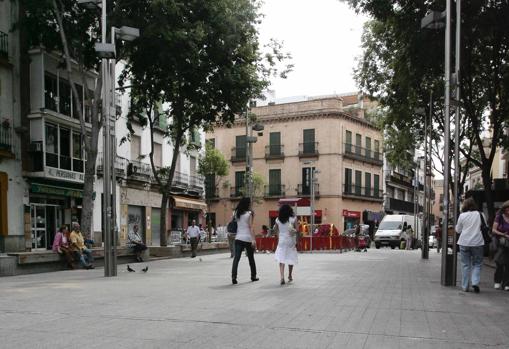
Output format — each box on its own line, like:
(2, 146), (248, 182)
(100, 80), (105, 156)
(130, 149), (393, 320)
(78, 0), (140, 277)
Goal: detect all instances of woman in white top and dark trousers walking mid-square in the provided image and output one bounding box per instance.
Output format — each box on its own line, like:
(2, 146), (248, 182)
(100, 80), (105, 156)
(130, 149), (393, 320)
(232, 198), (259, 285)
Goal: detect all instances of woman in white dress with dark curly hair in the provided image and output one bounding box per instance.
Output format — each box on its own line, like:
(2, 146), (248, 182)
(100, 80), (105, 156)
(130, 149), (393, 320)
(274, 205), (298, 285)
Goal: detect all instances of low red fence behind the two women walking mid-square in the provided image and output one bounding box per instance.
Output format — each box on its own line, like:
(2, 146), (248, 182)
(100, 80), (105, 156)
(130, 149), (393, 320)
(256, 236), (355, 252)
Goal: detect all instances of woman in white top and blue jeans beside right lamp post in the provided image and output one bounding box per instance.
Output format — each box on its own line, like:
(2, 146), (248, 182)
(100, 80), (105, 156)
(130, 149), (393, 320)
(456, 198), (484, 293)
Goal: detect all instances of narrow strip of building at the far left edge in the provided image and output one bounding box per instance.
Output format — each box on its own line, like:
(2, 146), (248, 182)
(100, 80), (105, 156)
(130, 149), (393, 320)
(0, 1), (24, 252)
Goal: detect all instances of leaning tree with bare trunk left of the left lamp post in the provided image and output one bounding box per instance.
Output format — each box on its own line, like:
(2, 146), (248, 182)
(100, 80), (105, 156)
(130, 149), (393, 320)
(19, 0), (103, 237)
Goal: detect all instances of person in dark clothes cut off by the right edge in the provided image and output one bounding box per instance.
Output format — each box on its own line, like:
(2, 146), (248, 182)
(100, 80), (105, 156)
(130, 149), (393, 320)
(491, 201), (509, 291)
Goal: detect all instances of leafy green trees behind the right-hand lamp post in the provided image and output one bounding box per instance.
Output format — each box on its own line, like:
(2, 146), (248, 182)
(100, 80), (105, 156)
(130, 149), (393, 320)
(343, 0), (509, 219)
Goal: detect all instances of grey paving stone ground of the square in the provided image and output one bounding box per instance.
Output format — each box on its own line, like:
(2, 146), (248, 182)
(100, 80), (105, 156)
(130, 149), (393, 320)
(0, 249), (509, 349)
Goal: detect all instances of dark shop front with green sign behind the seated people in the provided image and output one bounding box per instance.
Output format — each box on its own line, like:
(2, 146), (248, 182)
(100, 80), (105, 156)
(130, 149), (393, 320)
(27, 181), (83, 250)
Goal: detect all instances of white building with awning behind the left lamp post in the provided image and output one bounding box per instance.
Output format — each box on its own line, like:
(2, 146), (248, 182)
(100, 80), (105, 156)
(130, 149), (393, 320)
(93, 81), (206, 246)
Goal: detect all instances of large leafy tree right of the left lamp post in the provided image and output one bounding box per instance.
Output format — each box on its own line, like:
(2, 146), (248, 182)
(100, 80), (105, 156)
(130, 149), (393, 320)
(115, 0), (287, 246)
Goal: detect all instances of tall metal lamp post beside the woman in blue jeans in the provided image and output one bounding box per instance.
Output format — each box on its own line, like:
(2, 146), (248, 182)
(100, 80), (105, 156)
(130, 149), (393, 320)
(421, 0), (461, 286)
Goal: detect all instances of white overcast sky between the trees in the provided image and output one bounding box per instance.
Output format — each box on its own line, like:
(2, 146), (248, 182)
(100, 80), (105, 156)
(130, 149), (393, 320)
(260, 0), (367, 99)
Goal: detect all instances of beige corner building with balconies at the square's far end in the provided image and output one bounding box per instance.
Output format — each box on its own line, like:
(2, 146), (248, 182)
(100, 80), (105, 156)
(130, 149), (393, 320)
(206, 94), (383, 232)
